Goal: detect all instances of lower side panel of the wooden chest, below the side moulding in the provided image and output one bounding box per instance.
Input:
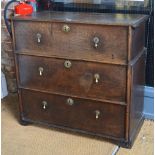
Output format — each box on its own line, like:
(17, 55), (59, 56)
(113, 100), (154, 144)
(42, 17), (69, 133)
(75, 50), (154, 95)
(129, 52), (146, 140)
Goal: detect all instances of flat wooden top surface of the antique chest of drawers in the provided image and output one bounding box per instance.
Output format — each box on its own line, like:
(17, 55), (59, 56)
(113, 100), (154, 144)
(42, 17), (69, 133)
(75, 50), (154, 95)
(13, 11), (148, 26)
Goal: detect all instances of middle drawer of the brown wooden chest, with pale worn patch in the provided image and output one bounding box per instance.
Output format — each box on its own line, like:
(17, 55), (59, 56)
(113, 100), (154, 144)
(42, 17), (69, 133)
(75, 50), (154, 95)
(18, 55), (126, 102)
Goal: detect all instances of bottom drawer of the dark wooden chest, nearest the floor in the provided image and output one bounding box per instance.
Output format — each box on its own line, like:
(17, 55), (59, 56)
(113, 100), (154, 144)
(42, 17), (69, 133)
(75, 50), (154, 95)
(21, 90), (125, 138)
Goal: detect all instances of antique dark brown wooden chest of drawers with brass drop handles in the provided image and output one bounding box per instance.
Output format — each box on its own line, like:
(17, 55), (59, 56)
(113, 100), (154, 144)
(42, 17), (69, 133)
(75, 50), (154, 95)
(12, 12), (148, 147)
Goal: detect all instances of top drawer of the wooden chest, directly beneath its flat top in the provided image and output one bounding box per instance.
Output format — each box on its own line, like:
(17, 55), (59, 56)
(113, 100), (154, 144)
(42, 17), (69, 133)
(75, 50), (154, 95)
(14, 21), (128, 63)
